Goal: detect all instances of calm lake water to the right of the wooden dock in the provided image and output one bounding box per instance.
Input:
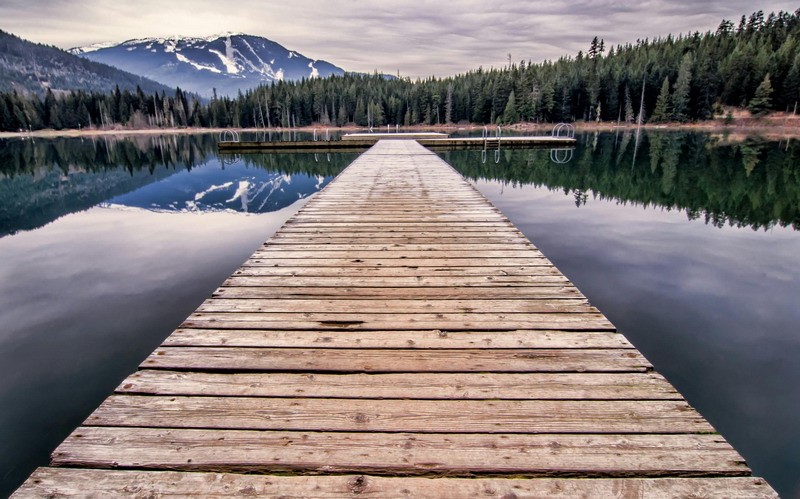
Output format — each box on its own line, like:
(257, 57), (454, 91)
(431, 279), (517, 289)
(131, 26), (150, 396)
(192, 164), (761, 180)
(443, 133), (800, 497)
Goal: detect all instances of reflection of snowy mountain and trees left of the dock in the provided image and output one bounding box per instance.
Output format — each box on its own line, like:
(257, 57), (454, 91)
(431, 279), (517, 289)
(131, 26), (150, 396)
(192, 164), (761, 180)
(0, 135), (355, 237)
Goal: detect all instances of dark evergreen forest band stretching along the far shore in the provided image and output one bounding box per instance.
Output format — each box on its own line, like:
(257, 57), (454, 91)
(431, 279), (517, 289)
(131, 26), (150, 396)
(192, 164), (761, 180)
(0, 10), (800, 130)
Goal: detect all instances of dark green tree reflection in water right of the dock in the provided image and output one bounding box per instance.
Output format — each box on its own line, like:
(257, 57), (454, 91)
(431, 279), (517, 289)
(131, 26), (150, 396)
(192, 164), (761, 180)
(443, 132), (800, 233)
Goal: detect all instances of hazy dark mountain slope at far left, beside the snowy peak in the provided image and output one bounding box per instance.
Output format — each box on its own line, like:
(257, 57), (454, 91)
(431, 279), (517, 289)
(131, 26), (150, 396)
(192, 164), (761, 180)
(0, 30), (175, 94)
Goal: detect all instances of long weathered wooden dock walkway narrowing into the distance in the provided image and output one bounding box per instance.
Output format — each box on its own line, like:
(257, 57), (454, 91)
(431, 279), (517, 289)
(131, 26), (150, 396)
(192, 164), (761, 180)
(15, 141), (775, 498)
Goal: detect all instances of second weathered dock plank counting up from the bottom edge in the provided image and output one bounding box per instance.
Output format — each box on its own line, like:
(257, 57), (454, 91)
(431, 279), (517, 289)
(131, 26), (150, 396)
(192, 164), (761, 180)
(52, 427), (750, 477)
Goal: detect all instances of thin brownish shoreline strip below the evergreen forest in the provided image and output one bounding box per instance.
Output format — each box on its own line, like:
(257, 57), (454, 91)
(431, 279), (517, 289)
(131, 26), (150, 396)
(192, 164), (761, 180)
(0, 116), (800, 140)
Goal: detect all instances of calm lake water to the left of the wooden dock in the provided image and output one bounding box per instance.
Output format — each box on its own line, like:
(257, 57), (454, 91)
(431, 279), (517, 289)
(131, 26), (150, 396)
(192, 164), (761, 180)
(0, 136), (355, 497)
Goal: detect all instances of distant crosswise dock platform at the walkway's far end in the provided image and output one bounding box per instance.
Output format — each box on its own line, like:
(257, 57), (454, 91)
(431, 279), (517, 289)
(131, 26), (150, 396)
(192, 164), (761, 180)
(219, 132), (575, 153)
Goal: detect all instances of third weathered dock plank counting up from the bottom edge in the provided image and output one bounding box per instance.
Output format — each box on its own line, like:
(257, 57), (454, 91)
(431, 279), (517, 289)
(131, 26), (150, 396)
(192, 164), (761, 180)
(83, 393), (714, 434)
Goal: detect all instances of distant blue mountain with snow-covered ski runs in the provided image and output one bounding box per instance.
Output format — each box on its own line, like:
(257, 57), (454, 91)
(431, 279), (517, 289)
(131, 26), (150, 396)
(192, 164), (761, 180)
(70, 33), (344, 97)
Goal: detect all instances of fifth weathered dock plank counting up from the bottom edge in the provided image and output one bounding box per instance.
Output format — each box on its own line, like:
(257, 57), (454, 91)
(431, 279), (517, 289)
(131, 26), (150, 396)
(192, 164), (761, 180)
(142, 347), (652, 373)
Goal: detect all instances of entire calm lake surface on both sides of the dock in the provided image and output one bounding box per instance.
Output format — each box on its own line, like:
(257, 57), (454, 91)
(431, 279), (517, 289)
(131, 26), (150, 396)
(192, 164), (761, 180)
(0, 132), (800, 497)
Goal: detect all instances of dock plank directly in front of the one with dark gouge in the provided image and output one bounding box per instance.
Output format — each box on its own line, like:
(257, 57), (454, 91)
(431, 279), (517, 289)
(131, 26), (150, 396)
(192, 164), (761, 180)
(162, 328), (633, 350)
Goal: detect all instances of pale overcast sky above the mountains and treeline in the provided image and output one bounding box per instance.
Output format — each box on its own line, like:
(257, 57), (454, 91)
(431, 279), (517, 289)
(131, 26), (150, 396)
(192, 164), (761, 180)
(0, 0), (798, 78)
